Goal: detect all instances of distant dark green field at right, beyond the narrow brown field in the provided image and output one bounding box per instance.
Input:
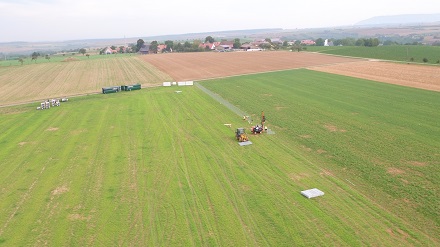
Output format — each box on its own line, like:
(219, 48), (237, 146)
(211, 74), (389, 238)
(307, 45), (440, 64)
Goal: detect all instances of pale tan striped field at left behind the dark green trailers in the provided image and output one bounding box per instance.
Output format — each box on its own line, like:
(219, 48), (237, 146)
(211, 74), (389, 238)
(0, 55), (170, 106)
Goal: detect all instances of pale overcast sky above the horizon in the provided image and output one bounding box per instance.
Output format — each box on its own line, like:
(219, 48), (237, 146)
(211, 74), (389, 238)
(0, 0), (440, 42)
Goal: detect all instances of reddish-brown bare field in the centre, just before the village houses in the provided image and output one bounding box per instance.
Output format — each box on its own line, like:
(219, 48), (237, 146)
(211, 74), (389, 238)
(142, 51), (361, 81)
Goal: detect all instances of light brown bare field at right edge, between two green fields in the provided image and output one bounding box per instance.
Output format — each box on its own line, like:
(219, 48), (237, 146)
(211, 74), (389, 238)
(309, 61), (440, 91)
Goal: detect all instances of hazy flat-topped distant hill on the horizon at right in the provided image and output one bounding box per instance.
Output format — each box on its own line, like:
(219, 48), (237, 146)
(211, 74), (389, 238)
(355, 14), (440, 26)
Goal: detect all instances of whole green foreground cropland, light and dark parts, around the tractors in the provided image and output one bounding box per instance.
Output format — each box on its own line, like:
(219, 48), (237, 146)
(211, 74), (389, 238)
(0, 70), (440, 246)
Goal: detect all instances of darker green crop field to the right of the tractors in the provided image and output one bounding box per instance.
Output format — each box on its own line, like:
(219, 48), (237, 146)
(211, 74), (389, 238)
(203, 70), (440, 245)
